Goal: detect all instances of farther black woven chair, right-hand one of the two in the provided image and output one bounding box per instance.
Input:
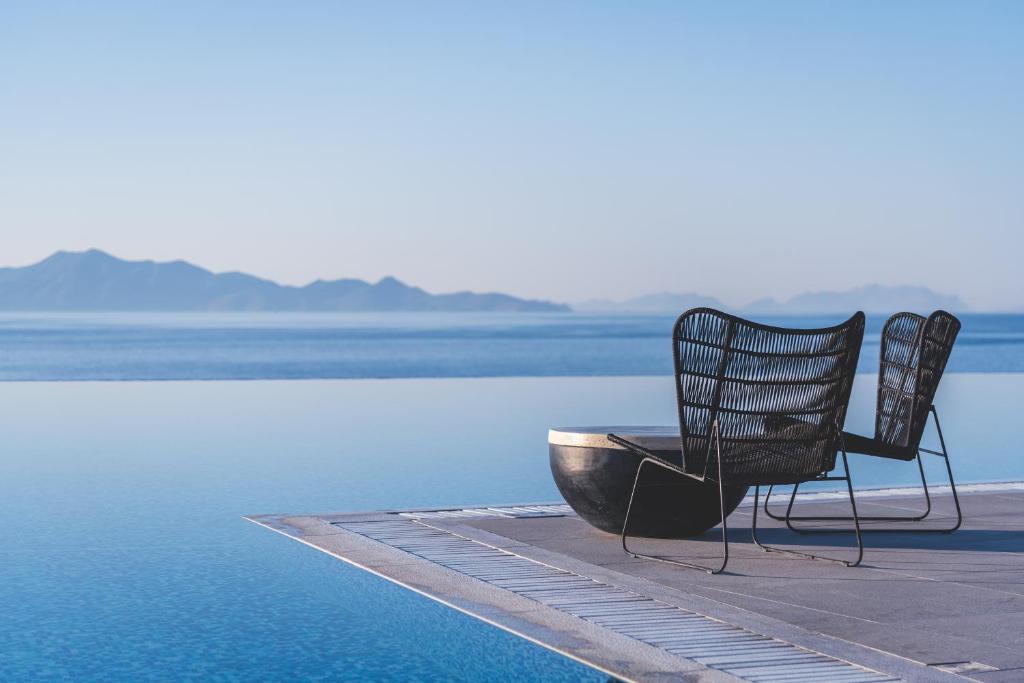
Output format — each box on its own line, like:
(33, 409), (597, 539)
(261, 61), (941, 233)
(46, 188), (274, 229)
(765, 310), (964, 533)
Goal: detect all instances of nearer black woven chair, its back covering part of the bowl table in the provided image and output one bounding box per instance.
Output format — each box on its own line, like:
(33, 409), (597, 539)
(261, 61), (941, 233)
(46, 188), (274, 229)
(608, 308), (864, 573)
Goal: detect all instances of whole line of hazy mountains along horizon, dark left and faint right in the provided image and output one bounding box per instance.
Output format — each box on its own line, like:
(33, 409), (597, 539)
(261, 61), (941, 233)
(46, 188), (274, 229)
(0, 249), (968, 315)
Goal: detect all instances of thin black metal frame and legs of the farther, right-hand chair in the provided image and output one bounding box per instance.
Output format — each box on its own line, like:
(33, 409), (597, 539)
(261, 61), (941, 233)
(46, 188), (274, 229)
(764, 310), (964, 533)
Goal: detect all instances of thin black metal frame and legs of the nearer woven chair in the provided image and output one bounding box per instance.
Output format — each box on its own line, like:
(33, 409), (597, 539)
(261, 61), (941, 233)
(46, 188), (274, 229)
(607, 308), (864, 574)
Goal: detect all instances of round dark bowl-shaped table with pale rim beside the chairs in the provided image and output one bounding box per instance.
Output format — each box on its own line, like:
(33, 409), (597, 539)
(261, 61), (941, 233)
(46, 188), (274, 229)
(548, 426), (748, 539)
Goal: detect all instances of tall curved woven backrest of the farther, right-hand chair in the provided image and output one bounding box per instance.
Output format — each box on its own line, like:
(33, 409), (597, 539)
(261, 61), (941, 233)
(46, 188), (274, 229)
(874, 310), (961, 451)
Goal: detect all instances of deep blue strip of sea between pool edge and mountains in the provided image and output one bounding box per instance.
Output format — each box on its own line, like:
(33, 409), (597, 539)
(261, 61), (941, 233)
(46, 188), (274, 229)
(0, 312), (1024, 380)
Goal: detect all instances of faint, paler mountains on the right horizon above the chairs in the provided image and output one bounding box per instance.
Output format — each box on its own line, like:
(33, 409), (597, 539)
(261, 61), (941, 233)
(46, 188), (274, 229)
(573, 285), (968, 315)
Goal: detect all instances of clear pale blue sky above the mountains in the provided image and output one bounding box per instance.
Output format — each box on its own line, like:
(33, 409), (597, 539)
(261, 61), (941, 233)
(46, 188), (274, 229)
(0, 0), (1024, 309)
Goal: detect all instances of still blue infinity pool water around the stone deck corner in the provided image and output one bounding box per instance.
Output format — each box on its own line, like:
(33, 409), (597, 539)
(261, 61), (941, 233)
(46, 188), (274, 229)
(0, 374), (1024, 681)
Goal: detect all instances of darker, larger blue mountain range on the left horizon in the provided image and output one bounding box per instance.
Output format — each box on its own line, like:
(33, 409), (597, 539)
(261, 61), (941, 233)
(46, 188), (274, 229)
(0, 249), (569, 311)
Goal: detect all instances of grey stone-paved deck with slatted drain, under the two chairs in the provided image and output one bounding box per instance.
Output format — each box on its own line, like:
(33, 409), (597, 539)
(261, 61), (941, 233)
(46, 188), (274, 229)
(250, 484), (1024, 683)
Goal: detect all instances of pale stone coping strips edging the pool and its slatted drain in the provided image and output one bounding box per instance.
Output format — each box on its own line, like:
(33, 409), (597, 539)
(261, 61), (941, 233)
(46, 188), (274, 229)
(246, 481), (1024, 681)
